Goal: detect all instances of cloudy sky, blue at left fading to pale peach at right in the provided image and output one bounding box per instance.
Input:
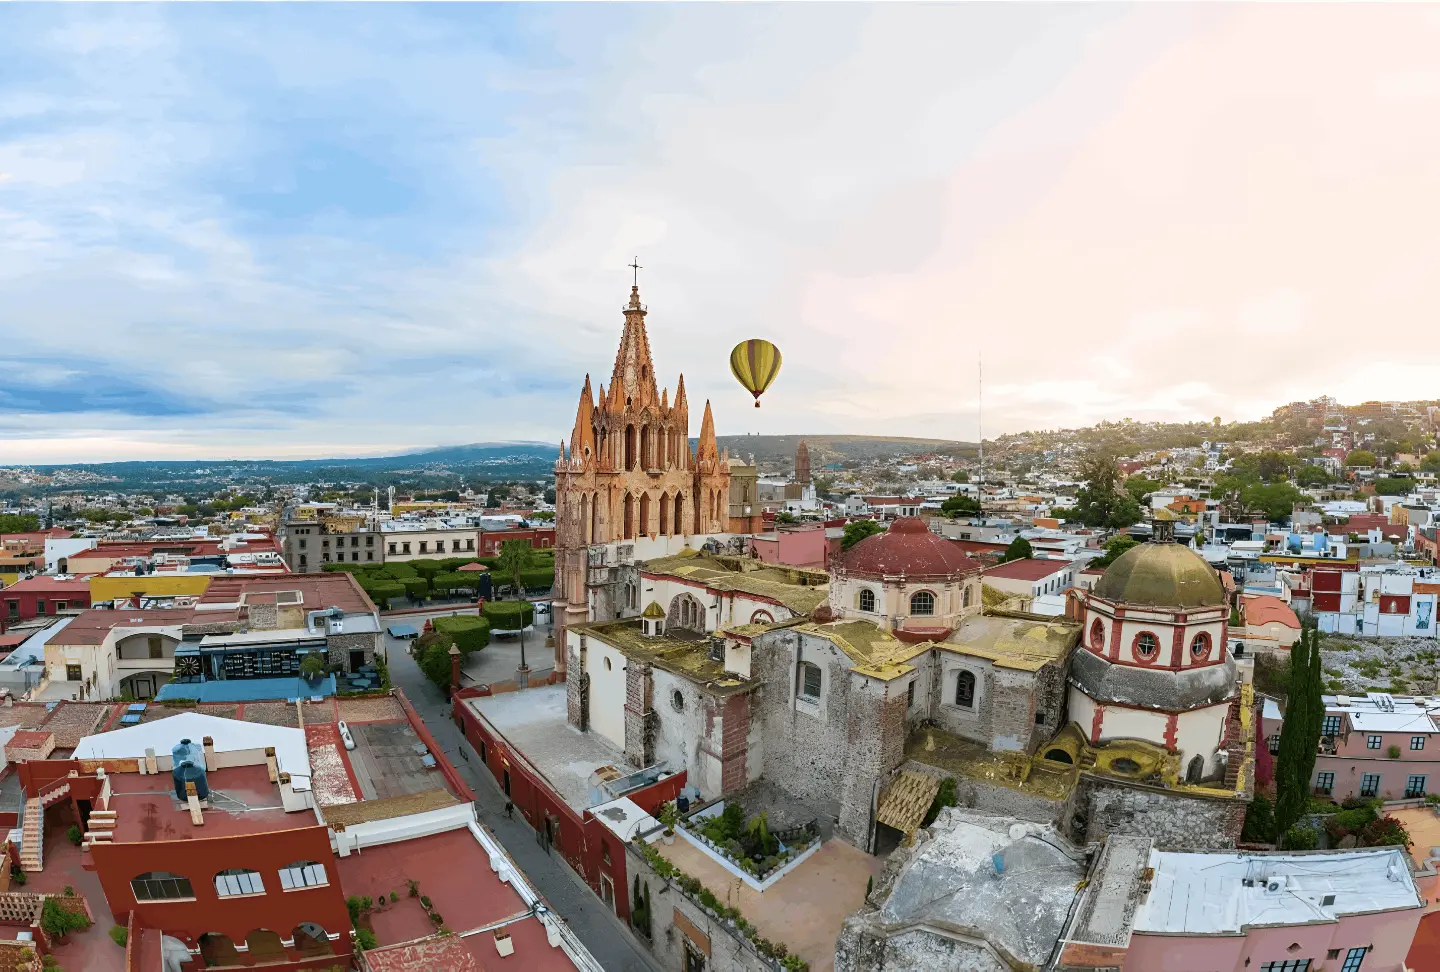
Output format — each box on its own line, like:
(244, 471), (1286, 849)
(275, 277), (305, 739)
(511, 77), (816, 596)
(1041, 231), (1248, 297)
(0, 3), (1440, 465)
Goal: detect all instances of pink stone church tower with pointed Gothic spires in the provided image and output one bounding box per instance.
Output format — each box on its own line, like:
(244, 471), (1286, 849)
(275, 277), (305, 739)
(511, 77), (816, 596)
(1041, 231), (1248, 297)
(553, 287), (730, 674)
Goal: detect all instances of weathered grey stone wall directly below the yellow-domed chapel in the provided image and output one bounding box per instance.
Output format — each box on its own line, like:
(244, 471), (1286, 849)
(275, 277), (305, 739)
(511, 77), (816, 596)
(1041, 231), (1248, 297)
(1068, 775), (1246, 850)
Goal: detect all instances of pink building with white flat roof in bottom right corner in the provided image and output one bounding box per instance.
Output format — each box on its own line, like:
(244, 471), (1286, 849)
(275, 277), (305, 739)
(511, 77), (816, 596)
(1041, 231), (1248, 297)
(1120, 847), (1424, 972)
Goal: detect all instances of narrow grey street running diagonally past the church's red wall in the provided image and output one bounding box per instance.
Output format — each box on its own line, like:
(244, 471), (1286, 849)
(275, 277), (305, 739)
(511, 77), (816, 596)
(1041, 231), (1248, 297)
(382, 624), (661, 972)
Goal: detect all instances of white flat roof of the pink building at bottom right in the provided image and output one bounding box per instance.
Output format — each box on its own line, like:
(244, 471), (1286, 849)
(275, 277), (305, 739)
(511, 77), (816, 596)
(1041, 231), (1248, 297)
(1135, 847), (1421, 935)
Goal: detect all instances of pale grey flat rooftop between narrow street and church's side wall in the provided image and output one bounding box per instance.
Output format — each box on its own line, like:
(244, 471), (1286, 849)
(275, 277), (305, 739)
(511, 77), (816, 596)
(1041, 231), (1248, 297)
(465, 685), (629, 811)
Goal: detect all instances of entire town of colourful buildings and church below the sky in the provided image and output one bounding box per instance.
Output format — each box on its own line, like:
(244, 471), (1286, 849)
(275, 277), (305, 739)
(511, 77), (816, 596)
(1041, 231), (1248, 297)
(0, 284), (1440, 972)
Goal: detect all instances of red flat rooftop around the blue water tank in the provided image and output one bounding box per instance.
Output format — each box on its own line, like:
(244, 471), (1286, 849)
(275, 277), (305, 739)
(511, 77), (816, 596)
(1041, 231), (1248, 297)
(109, 766), (308, 844)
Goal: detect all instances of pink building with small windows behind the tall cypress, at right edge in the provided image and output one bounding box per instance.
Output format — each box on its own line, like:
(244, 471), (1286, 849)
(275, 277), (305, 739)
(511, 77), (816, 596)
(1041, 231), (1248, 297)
(1261, 693), (1440, 802)
